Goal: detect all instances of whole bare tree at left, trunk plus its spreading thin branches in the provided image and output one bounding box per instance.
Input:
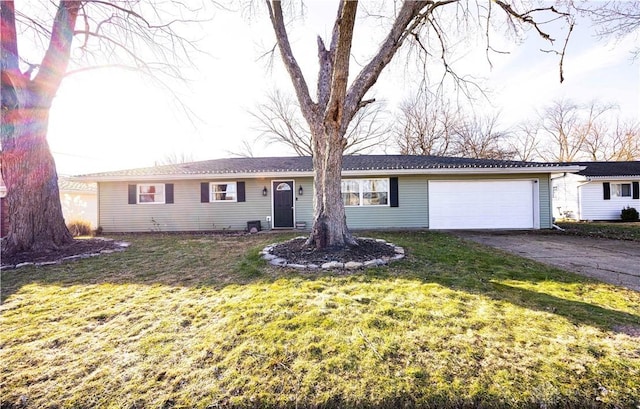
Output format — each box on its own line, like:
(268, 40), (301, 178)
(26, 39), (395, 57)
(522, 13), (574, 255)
(0, 0), (205, 252)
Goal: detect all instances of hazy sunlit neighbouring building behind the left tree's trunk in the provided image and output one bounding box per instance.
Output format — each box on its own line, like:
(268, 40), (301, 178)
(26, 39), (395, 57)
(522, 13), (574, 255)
(0, 176), (98, 237)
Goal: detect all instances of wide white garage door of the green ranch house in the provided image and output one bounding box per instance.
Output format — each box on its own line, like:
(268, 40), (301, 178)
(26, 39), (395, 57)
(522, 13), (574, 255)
(429, 180), (540, 229)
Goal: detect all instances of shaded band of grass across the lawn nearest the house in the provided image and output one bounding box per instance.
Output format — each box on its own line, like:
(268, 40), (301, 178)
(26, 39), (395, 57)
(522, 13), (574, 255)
(1, 231), (640, 331)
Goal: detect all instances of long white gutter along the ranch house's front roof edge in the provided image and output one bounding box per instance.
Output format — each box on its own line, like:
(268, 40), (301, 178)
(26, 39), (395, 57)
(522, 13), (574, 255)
(71, 165), (585, 182)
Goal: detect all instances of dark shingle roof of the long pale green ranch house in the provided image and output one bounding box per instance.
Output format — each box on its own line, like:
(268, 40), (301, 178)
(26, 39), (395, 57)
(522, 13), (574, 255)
(76, 155), (576, 179)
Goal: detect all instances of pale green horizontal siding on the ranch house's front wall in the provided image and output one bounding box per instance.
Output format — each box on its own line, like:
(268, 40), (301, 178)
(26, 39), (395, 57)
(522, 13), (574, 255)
(98, 174), (552, 233)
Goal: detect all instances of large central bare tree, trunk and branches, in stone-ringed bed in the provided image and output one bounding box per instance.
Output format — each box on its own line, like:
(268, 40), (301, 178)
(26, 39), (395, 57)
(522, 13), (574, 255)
(267, 0), (573, 248)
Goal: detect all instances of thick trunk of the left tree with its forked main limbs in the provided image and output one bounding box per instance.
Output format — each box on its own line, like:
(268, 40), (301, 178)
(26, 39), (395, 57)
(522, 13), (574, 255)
(0, 0), (81, 254)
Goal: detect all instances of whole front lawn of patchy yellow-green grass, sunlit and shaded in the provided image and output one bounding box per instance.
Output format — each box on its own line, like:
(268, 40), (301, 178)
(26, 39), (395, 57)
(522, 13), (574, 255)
(0, 232), (640, 408)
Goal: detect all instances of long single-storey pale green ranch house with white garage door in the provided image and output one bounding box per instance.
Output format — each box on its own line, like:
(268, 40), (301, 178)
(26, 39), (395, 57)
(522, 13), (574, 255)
(75, 155), (581, 232)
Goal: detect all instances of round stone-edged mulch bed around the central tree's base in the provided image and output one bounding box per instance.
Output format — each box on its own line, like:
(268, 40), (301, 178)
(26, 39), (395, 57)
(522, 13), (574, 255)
(271, 238), (395, 265)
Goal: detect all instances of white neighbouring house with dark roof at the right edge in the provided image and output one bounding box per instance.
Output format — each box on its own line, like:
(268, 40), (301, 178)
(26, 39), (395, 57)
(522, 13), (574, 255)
(552, 161), (640, 220)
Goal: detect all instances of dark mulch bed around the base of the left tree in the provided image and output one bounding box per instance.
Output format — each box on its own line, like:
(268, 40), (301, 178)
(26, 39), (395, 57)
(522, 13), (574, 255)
(1, 239), (121, 266)
